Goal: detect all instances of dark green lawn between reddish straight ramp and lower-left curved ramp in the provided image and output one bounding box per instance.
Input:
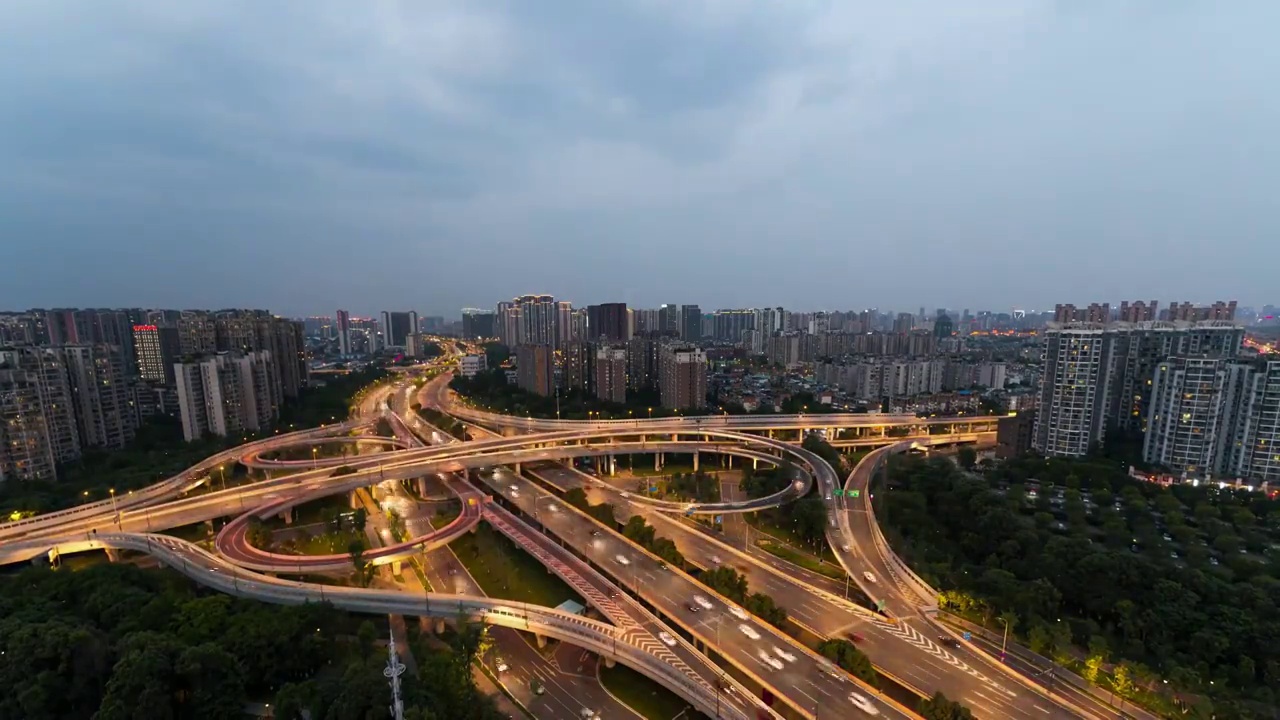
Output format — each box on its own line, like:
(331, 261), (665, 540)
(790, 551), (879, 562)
(449, 524), (585, 607)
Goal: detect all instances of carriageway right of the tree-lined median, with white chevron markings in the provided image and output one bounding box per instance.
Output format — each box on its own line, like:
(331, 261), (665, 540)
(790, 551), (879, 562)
(524, 465), (1054, 716)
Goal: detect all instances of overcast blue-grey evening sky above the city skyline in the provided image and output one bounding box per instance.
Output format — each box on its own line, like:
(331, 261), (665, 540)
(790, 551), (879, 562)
(0, 0), (1280, 316)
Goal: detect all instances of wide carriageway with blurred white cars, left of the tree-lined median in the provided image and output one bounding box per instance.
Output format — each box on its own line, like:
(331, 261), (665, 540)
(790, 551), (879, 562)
(481, 470), (900, 717)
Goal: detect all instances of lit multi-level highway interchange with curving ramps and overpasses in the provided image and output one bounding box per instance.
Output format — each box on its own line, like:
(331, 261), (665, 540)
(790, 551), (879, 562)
(0, 353), (1100, 719)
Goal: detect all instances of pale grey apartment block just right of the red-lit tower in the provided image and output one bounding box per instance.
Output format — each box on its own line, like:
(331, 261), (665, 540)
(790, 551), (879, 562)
(174, 351), (279, 442)
